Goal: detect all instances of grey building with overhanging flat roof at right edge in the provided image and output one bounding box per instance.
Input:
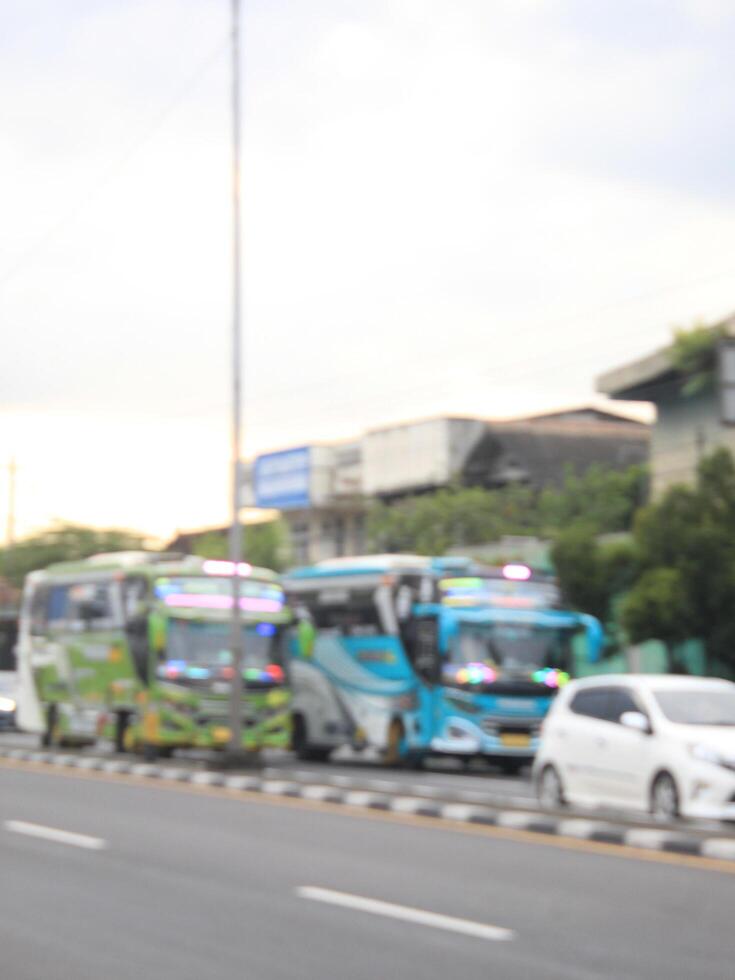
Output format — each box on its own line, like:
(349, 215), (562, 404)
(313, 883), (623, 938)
(597, 317), (735, 497)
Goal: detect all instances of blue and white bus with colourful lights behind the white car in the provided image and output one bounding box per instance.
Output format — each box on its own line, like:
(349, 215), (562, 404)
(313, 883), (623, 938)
(284, 555), (603, 772)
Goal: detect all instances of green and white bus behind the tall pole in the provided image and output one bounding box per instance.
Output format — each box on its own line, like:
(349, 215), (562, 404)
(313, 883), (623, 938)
(17, 552), (291, 758)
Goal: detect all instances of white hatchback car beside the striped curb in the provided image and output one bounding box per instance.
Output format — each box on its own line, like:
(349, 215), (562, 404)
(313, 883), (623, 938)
(533, 674), (735, 820)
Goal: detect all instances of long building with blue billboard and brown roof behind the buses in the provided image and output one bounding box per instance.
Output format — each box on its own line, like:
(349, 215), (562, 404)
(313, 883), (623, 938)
(242, 407), (648, 564)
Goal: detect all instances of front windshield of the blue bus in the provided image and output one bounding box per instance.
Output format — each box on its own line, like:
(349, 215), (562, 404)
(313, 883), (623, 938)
(449, 623), (573, 671)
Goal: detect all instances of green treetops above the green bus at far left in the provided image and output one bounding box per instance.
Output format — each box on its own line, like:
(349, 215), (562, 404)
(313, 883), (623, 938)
(0, 521), (144, 586)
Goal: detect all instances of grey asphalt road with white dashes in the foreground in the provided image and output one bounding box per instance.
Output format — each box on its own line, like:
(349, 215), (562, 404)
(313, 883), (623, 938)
(0, 767), (735, 980)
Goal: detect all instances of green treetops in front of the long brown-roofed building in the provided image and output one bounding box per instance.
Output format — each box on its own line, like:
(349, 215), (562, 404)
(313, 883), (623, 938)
(367, 465), (647, 555)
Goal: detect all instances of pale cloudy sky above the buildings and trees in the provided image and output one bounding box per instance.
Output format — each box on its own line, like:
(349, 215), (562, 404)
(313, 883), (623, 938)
(0, 0), (735, 539)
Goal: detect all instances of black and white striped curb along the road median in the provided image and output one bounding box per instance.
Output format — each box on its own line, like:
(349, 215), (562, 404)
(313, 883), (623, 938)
(0, 749), (735, 861)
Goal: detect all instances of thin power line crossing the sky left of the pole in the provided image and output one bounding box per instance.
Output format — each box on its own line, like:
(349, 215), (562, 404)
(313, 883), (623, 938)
(0, 36), (228, 286)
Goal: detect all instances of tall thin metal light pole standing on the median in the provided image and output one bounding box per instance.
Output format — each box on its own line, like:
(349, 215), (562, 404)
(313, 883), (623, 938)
(230, 0), (245, 761)
